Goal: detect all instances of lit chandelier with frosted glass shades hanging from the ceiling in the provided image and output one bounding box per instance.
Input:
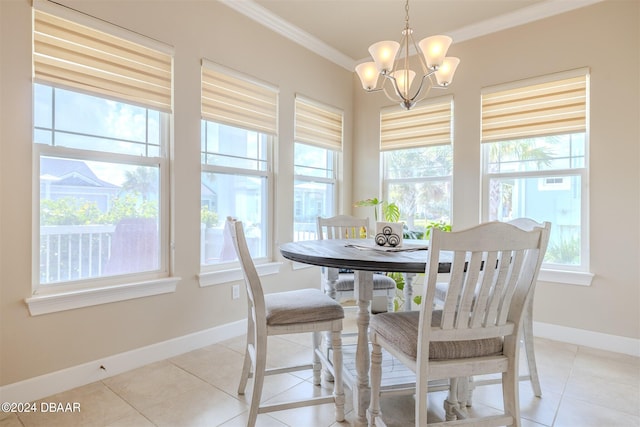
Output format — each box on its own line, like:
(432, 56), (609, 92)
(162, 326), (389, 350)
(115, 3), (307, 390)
(356, 0), (460, 110)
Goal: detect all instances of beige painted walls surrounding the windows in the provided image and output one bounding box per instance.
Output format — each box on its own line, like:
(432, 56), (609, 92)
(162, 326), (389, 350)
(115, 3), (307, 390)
(0, 0), (640, 385)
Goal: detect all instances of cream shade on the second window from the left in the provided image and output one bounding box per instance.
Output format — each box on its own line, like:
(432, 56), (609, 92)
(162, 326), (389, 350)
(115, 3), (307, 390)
(202, 60), (278, 135)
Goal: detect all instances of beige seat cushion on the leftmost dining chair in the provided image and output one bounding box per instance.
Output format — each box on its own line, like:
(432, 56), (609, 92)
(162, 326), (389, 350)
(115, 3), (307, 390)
(264, 289), (344, 326)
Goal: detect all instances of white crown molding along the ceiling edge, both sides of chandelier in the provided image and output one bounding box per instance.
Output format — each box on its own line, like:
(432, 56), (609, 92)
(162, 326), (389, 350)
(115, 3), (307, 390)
(218, 0), (604, 71)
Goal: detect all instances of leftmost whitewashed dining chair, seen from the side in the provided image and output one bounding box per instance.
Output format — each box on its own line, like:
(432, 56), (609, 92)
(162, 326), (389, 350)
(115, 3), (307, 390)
(225, 218), (345, 427)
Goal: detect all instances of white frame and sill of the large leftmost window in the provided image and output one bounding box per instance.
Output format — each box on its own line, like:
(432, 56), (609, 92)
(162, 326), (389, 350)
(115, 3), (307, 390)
(25, 0), (180, 316)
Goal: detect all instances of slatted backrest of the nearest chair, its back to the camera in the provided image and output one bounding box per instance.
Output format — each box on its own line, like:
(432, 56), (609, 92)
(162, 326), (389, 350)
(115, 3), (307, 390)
(419, 222), (551, 354)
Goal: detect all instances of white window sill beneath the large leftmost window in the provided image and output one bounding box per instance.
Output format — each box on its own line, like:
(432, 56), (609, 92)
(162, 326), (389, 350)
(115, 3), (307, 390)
(25, 277), (180, 316)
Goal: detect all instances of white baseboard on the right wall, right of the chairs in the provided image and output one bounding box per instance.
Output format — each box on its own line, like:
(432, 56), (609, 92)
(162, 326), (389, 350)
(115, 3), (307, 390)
(533, 322), (640, 357)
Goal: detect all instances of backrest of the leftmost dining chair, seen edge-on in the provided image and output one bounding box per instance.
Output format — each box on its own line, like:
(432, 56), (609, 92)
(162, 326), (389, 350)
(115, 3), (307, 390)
(225, 217), (266, 326)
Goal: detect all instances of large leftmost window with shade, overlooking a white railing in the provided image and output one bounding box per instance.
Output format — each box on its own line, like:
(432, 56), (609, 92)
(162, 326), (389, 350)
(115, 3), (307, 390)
(33, 8), (172, 305)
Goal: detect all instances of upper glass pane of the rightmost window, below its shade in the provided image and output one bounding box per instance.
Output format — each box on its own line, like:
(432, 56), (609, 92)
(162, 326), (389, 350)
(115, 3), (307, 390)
(487, 133), (585, 173)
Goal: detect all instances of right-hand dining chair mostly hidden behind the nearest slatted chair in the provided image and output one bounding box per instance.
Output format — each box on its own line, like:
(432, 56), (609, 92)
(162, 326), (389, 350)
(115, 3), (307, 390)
(436, 217), (551, 406)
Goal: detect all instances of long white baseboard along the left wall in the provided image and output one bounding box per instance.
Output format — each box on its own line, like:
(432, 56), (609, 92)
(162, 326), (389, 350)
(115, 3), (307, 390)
(0, 320), (247, 402)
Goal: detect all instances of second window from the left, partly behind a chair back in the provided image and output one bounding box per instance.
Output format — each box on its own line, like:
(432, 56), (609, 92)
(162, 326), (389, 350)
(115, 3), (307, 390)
(200, 60), (278, 266)
